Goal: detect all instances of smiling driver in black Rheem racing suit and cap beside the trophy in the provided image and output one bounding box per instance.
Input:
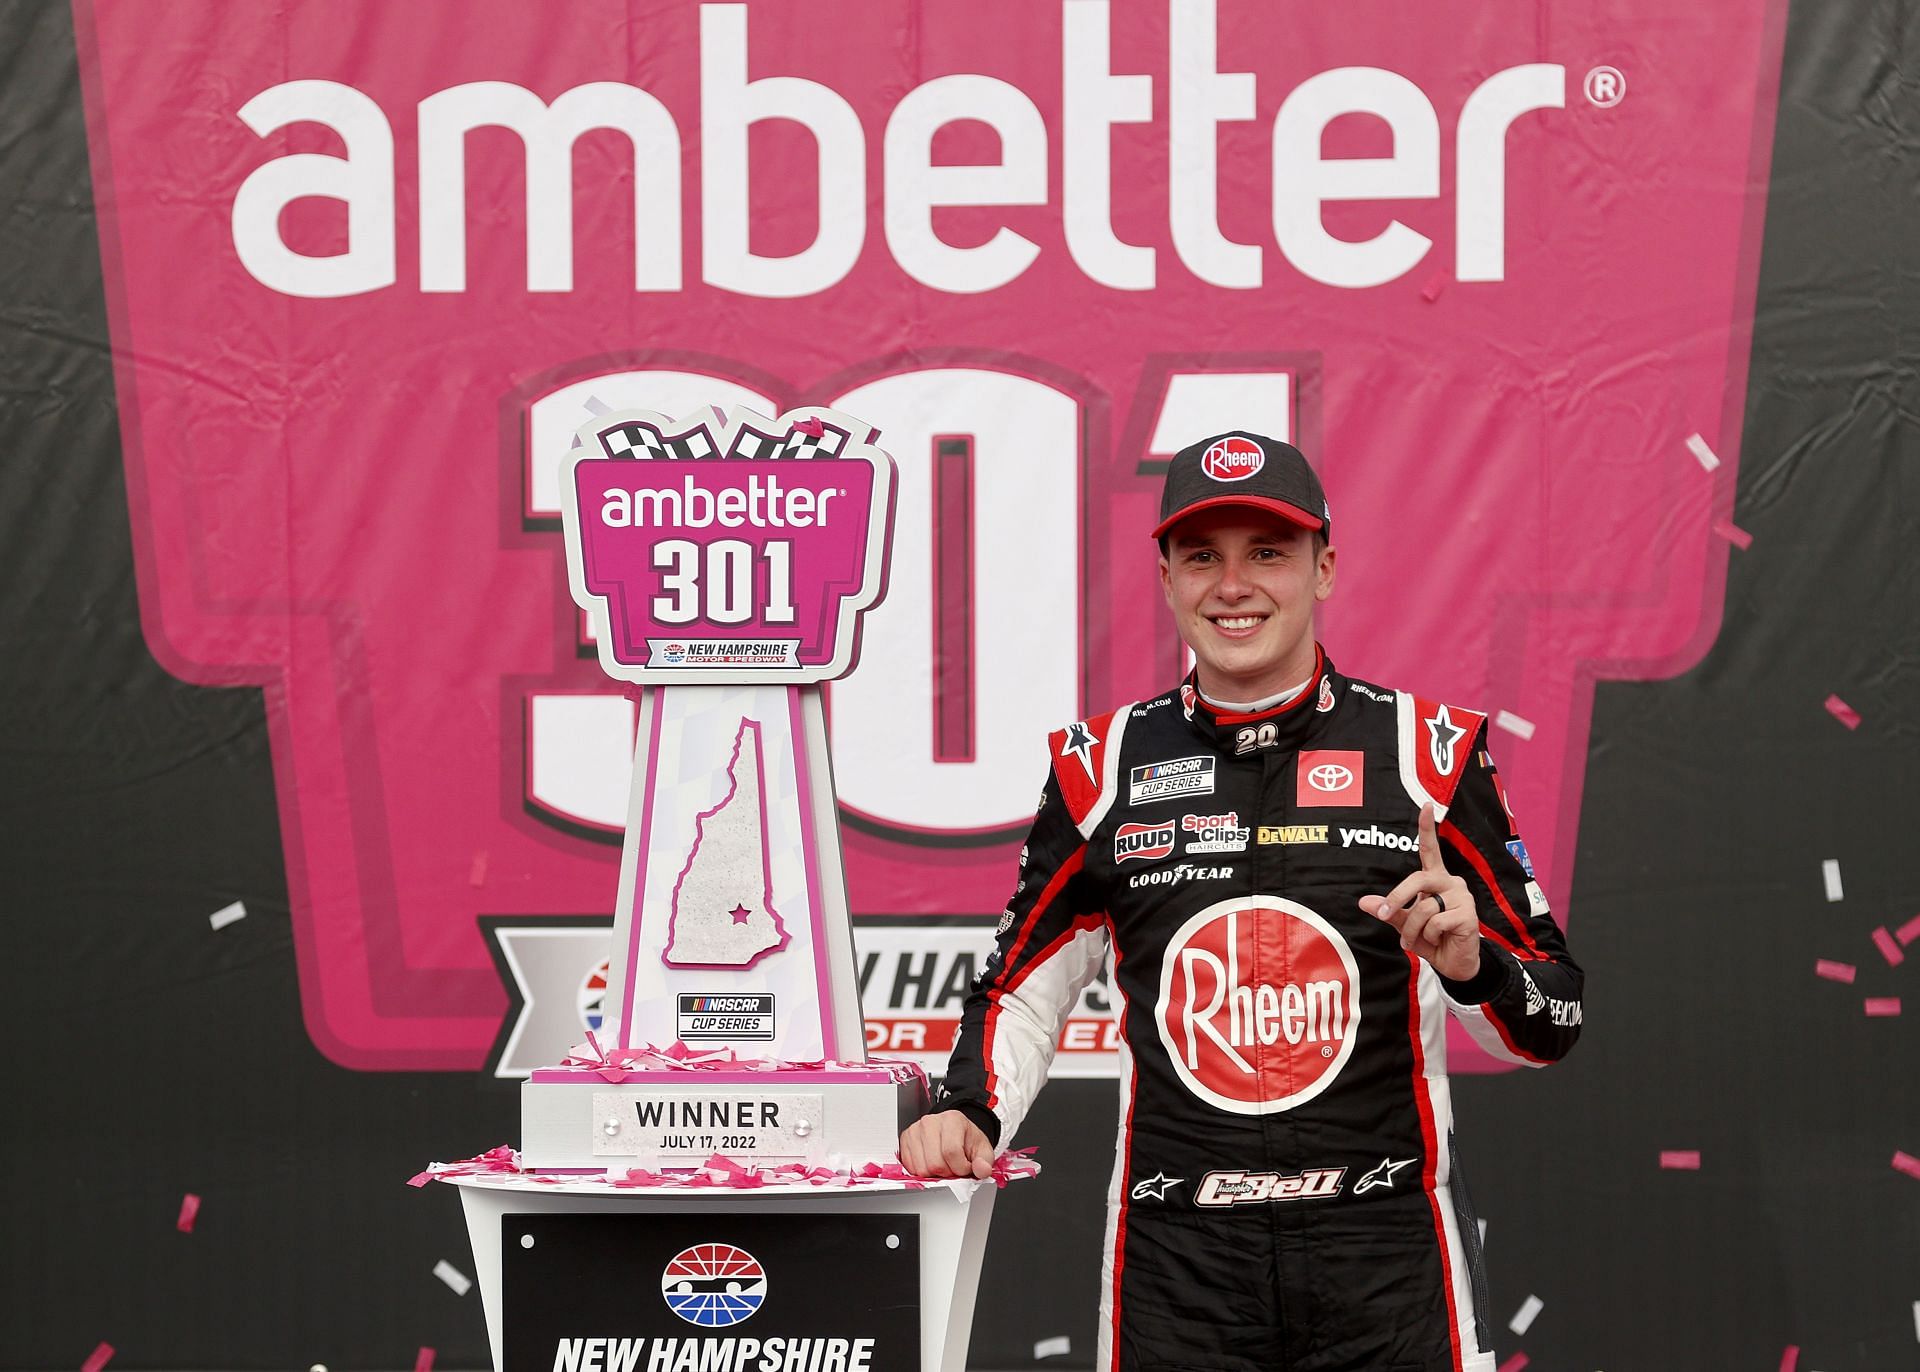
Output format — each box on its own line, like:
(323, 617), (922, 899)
(900, 432), (1580, 1372)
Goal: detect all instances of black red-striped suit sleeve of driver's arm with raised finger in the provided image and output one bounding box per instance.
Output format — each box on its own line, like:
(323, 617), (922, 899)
(1438, 744), (1584, 1067)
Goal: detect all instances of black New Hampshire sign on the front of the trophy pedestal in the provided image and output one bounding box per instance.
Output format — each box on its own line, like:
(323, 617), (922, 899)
(499, 1213), (920, 1372)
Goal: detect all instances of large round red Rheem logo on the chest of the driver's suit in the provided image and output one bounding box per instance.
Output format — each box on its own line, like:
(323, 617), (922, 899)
(1154, 896), (1359, 1115)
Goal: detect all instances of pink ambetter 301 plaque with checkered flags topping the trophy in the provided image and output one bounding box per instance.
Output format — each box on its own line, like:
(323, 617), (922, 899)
(561, 407), (895, 685)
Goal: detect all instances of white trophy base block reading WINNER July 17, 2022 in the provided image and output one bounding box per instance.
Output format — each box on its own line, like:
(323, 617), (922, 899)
(520, 1067), (927, 1172)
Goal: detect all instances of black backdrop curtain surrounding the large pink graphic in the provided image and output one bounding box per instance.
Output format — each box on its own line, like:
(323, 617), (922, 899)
(0, 0), (1920, 1372)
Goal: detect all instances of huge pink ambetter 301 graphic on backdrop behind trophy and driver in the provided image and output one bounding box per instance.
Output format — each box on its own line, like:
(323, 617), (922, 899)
(75, 0), (1782, 1071)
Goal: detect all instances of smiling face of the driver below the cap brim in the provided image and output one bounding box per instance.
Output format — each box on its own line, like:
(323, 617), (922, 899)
(1160, 507), (1334, 702)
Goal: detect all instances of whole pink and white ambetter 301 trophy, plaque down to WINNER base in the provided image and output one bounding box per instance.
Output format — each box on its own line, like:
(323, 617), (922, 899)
(522, 409), (924, 1171)
